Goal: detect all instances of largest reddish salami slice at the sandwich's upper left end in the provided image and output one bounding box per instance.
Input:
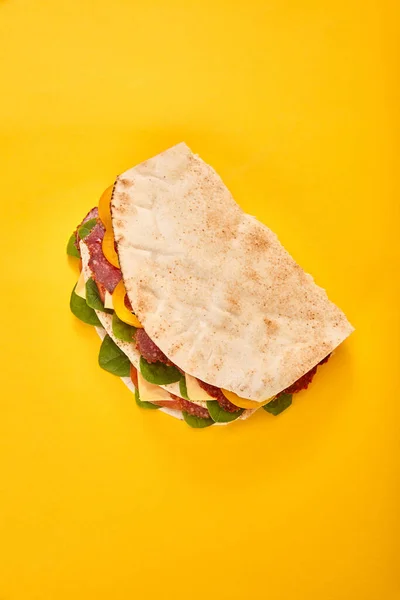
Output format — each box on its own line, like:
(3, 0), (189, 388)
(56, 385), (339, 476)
(85, 223), (121, 294)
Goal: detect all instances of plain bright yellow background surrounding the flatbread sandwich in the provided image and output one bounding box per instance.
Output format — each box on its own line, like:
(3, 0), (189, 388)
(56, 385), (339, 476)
(0, 0), (400, 600)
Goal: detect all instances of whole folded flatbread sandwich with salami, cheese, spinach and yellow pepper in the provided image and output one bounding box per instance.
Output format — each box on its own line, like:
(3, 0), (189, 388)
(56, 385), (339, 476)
(67, 143), (353, 428)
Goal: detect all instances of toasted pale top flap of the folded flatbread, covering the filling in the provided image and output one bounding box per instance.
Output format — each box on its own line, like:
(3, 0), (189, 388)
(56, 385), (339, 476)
(111, 143), (353, 400)
